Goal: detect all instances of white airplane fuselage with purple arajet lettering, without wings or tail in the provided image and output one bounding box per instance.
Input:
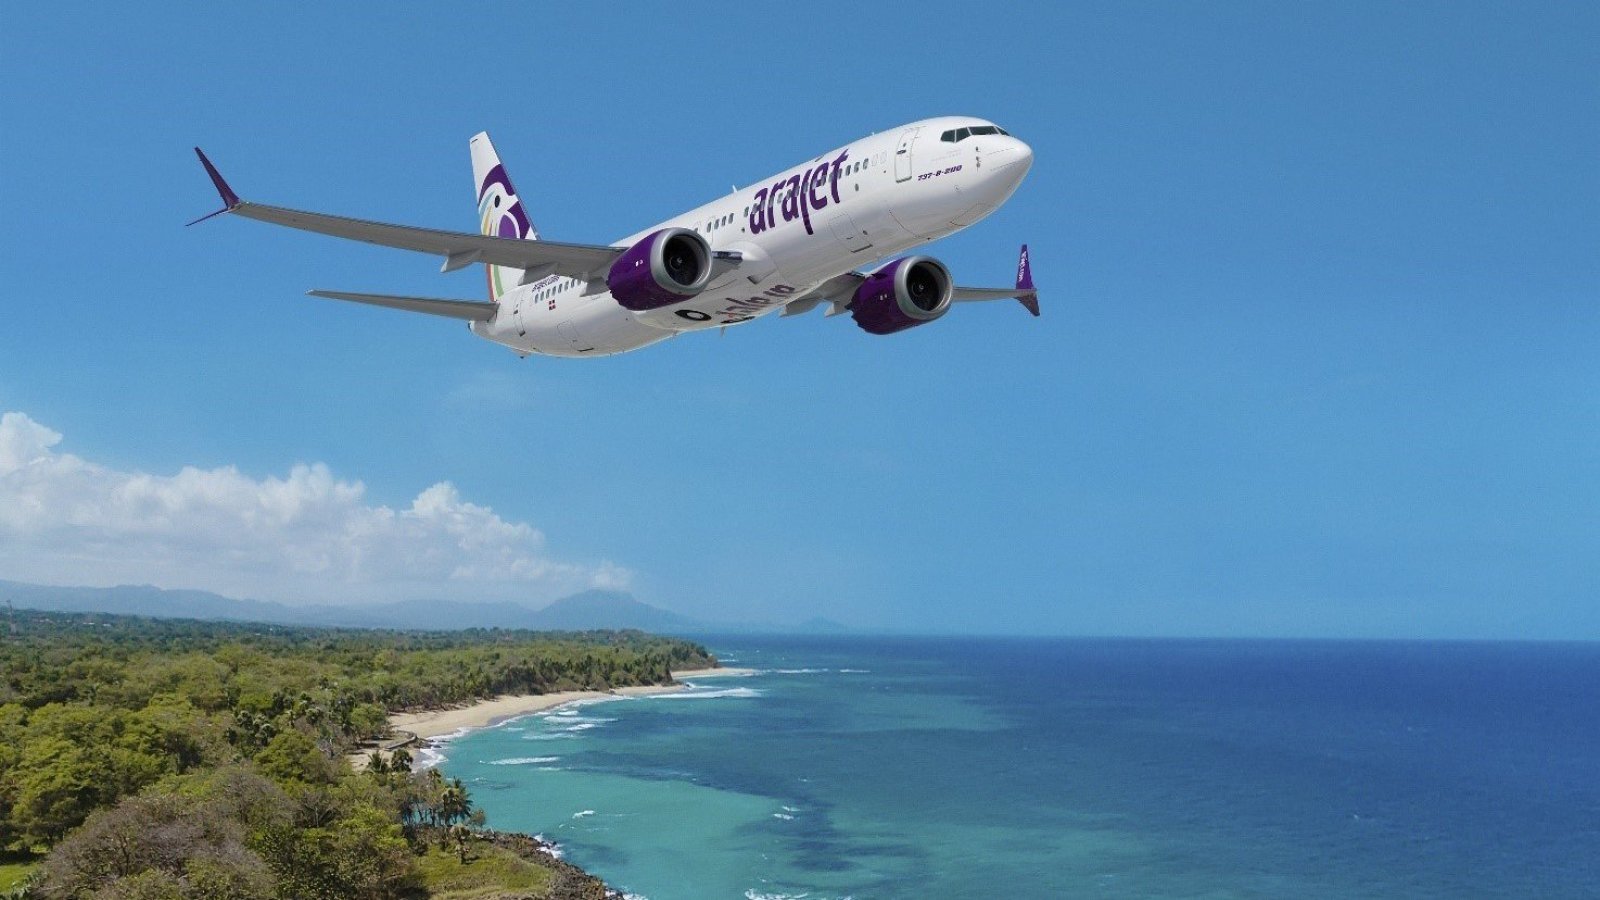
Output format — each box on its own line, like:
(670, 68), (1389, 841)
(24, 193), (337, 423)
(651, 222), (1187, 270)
(472, 117), (1032, 357)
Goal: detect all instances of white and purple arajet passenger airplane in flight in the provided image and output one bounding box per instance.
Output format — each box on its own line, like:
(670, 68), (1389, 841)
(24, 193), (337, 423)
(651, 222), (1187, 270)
(189, 115), (1038, 357)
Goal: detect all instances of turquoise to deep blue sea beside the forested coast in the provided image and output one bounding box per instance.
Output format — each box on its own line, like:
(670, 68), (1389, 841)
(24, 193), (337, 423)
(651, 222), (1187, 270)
(443, 637), (1600, 900)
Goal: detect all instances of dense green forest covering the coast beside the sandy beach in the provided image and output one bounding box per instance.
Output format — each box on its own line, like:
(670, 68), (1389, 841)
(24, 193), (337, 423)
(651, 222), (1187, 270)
(0, 610), (715, 900)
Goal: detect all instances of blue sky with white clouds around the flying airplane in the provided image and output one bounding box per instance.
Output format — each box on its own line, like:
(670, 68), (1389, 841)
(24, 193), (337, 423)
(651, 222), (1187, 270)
(0, 2), (1600, 639)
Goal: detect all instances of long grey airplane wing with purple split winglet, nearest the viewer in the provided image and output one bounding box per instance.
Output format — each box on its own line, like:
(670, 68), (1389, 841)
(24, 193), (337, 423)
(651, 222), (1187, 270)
(189, 147), (627, 280)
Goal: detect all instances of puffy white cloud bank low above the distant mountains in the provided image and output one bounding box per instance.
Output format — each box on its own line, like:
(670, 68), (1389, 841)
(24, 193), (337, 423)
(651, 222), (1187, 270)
(0, 412), (629, 602)
